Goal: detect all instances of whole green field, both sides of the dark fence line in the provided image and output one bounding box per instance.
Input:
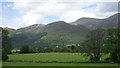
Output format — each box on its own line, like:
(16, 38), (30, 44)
(3, 53), (117, 66)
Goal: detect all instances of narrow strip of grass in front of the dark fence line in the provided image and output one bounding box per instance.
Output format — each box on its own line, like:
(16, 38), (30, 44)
(3, 62), (118, 66)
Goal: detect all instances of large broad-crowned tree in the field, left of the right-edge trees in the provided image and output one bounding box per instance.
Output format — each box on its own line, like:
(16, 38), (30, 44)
(80, 29), (106, 61)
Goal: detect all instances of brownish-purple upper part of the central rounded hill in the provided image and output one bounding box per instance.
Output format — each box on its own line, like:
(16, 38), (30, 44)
(44, 21), (89, 36)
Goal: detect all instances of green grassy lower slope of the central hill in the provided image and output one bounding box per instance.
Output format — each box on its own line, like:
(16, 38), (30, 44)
(38, 31), (84, 45)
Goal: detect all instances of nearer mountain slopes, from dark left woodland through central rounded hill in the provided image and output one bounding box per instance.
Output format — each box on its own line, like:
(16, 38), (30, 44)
(8, 21), (89, 48)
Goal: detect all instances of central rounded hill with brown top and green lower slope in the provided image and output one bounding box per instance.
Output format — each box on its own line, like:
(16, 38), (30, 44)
(39, 21), (89, 45)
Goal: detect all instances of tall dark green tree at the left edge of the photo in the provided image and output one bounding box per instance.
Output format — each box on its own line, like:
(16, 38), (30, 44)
(0, 28), (12, 61)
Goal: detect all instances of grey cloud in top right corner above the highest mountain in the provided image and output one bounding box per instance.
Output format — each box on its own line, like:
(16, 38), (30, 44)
(95, 2), (118, 17)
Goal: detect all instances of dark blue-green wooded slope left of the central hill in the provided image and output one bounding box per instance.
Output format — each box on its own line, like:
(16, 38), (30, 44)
(11, 32), (47, 48)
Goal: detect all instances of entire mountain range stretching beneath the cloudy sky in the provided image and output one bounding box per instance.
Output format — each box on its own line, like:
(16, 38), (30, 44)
(4, 13), (120, 48)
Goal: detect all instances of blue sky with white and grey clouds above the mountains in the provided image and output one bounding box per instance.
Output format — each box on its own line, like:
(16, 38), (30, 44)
(0, 0), (119, 29)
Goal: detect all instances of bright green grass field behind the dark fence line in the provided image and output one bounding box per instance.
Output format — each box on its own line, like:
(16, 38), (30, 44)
(8, 53), (108, 62)
